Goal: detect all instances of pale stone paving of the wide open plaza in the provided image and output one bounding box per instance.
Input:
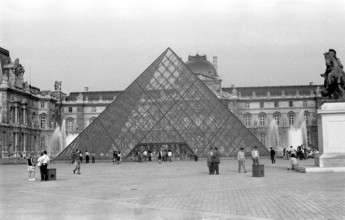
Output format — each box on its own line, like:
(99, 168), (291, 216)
(0, 159), (345, 220)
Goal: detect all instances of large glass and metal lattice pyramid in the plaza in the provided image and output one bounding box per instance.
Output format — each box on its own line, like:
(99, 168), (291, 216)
(56, 48), (269, 160)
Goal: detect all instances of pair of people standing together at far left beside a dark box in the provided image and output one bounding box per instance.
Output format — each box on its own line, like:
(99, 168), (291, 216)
(27, 151), (50, 181)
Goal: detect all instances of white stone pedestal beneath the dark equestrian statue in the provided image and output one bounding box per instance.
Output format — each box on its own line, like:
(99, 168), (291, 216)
(315, 101), (345, 167)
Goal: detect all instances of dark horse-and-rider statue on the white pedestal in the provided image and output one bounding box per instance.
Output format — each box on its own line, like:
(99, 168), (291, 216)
(321, 49), (345, 99)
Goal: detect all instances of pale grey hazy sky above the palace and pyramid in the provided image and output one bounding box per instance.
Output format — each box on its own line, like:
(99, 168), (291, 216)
(0, 0), (345, 94)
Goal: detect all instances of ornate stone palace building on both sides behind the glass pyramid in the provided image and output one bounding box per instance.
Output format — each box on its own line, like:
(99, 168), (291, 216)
(0, 48), (324, 158)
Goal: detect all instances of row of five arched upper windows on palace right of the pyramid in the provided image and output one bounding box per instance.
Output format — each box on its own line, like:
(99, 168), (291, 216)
(243, 111), (310, 127)
